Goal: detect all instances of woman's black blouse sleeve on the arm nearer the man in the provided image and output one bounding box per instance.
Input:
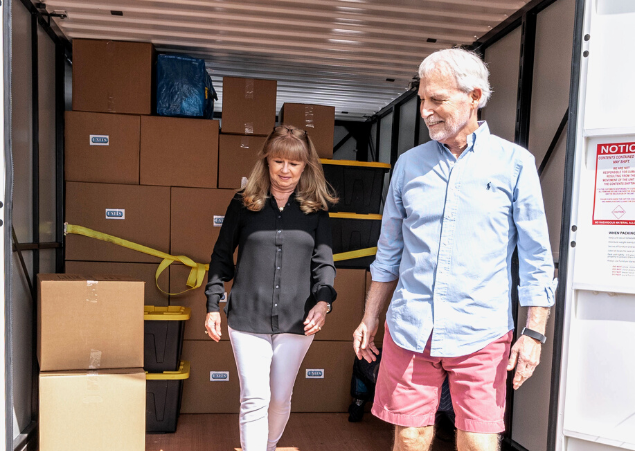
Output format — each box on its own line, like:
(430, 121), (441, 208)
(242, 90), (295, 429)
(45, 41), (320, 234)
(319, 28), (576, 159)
(311, 211), (337, 303)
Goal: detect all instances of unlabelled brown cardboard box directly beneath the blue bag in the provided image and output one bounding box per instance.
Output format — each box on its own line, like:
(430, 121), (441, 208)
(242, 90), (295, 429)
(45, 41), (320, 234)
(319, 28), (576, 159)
(140, 116), (218, 188)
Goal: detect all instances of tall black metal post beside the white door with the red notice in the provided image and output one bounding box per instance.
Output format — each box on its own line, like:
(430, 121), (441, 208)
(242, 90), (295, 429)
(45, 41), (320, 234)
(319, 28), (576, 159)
(547, 0), (585, 451)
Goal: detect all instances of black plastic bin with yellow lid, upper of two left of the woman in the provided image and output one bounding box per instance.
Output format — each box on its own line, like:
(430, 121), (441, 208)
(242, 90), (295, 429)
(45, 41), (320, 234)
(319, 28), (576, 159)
(143, 305), (191, 373)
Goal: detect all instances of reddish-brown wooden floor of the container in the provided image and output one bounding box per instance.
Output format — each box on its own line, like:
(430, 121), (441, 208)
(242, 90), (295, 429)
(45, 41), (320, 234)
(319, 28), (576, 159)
(146, 413), (454, 451)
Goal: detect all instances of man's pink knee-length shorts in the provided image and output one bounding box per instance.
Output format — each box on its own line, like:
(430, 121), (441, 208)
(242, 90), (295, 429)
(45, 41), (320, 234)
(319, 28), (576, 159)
(372, 329), (513, 433)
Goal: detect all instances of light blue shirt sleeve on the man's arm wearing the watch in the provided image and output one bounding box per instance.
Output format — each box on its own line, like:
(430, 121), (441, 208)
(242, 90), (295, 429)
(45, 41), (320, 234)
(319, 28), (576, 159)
(513, 157), (557, 307)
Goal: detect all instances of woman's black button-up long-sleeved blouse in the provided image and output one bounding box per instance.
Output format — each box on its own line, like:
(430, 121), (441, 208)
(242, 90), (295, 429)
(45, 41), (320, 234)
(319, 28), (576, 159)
(205, 193), (337, 334)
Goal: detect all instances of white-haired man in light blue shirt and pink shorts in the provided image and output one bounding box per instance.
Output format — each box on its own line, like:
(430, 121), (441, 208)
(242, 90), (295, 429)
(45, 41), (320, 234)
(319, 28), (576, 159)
(354, 49), (555, 451)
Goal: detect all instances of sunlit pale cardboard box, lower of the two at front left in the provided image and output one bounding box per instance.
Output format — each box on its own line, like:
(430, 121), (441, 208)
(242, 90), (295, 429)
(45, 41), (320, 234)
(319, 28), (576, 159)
(39, 368), (146, 451)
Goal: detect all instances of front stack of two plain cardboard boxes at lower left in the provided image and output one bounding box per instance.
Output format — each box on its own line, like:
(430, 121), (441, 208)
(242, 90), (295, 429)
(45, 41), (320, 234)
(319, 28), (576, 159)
(37, 274), (146, 451)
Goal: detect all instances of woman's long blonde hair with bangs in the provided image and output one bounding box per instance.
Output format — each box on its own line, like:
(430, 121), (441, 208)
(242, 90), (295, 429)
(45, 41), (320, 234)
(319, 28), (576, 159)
(243, 125), (338, 214)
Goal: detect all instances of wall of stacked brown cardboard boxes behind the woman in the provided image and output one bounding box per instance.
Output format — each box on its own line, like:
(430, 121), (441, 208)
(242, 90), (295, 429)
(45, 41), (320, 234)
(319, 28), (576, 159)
(65, 40), (366, 413)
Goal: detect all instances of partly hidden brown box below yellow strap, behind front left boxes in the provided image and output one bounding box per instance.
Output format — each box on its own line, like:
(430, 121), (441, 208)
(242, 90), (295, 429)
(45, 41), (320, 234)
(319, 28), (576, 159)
(64, 260), (172, 306)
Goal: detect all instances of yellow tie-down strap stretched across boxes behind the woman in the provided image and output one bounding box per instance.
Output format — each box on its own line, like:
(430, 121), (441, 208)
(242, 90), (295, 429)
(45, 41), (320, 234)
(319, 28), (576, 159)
(64, 223), (377, 296)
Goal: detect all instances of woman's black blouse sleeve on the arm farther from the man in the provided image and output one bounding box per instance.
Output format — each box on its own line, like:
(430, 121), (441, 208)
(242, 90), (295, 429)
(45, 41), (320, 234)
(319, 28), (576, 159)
(205, 194), (242, 313)
